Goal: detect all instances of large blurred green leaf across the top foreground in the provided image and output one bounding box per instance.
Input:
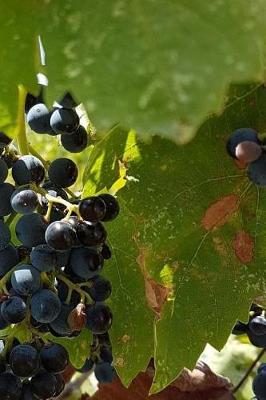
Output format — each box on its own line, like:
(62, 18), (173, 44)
(0, 0), (266, 142)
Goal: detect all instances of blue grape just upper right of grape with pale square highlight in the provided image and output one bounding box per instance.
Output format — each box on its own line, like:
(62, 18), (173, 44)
(30, 244), (57, 272)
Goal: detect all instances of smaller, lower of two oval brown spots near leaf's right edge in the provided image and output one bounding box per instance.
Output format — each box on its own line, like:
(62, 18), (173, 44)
(233, 231), (254, 264)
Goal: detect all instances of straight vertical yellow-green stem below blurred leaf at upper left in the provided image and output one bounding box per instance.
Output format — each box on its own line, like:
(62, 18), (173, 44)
(16, 85), (29, 155)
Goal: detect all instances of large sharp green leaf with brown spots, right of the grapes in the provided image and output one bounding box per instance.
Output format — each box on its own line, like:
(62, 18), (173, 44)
(84, 86), (266, 393)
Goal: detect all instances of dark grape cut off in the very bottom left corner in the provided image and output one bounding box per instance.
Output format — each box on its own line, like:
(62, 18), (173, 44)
(0, 372), (22, 400)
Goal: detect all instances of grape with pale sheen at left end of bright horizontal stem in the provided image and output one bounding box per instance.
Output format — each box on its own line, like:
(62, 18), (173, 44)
(11, 189), (38, 214)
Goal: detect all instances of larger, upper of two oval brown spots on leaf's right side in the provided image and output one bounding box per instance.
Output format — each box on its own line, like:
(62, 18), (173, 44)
(201, 194), (239, 231)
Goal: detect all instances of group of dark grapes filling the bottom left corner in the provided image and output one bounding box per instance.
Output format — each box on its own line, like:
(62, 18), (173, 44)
(0, 340), (69, 400)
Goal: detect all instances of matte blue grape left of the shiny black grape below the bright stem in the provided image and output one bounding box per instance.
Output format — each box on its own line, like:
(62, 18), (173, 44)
(15, 213), (48, 248)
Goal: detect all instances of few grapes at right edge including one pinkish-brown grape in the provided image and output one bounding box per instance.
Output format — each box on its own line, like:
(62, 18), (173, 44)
(226, 128), (266, 187)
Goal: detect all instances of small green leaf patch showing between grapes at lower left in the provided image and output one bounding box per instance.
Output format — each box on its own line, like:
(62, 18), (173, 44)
(46, 329), (92, 369)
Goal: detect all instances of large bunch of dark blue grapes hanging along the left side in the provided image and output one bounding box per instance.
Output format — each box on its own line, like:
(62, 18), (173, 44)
(0, 91), (119, 400)
